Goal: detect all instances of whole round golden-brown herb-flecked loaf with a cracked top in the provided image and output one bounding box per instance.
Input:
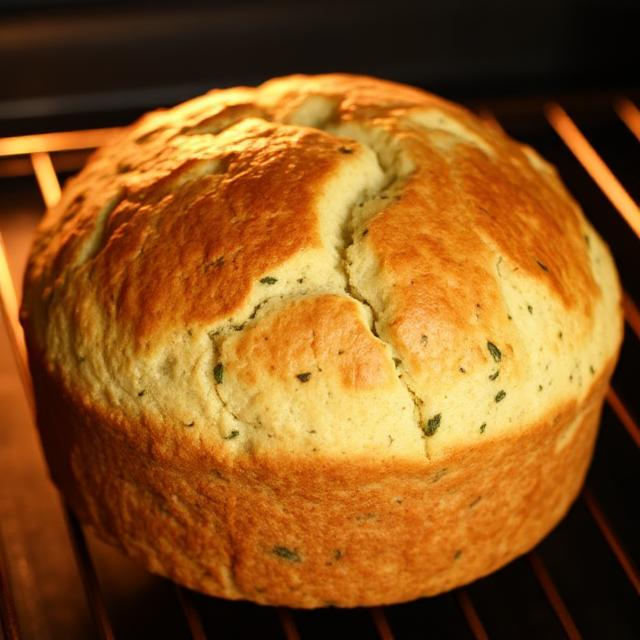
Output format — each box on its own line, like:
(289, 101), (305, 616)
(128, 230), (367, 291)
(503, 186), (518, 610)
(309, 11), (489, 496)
(22, 75), (622, 607)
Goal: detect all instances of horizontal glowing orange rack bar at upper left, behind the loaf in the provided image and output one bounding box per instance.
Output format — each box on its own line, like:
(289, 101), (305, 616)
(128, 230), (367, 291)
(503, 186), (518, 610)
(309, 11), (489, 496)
(0, 128), (120, 157)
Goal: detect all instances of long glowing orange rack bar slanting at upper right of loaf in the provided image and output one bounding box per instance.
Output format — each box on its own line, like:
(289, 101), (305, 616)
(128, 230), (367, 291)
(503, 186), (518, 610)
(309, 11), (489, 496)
(545, 104), (640, 238)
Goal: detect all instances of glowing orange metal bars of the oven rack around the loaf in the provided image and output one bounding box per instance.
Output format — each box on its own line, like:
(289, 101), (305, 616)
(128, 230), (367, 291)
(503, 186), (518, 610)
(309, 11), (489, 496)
(0, 99), (640, 640)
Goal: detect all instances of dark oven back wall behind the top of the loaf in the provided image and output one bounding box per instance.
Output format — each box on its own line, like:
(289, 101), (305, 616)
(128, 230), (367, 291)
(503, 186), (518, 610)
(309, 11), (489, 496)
(0, 0), (640, 135)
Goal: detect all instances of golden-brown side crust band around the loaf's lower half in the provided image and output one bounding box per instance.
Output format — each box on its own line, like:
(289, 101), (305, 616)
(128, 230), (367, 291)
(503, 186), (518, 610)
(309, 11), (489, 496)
(34, 350), (615, 607)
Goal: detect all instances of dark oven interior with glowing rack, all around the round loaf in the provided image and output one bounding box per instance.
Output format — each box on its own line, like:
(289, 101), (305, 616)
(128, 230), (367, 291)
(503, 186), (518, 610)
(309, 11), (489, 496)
(0, 2), (640, 640)
